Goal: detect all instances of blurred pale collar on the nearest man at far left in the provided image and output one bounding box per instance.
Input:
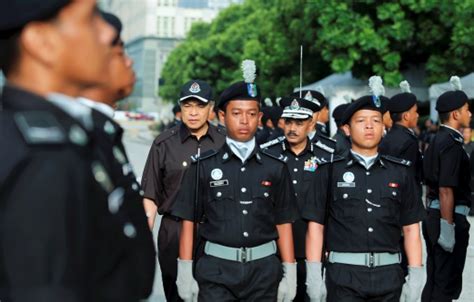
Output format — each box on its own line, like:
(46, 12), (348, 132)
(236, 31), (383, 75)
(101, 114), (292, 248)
(46, 93), (94, 130)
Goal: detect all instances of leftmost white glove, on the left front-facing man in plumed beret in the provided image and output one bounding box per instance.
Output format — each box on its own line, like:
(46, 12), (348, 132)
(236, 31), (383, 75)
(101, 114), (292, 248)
(176, 258), (199, 302)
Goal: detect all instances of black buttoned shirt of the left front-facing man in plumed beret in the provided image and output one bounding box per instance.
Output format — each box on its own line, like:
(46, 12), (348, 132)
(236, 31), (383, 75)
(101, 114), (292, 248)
(172, 144), (297, 247)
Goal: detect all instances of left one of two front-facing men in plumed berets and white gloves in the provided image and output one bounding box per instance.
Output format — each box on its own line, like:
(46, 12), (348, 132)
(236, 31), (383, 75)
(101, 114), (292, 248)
(172, 60), (296, 302)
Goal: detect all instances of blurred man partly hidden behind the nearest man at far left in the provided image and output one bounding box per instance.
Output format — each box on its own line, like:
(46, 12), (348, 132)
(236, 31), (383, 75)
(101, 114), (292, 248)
(79, 13), (156, 301)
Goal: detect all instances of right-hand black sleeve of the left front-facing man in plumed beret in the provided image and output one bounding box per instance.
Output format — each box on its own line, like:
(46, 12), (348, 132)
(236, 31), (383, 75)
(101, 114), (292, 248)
(272, 164), (298, 224)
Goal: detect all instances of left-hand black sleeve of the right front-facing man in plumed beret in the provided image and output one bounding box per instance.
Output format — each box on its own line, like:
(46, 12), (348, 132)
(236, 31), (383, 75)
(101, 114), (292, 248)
(301, 164), (332, 224)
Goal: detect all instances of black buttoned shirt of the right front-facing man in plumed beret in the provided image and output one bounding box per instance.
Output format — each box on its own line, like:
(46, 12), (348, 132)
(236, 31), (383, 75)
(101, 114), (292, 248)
(302, 152), (424, 253)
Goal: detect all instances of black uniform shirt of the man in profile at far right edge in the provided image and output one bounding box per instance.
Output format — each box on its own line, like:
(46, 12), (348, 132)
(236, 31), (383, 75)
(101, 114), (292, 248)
(423, 125), (471, 207)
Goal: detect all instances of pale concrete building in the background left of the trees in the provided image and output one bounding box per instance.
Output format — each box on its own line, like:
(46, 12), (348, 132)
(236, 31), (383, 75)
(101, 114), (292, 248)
(99, 0), (243, 111)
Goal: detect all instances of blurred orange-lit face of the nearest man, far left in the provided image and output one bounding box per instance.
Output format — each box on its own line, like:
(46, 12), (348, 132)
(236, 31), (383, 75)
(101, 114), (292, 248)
(47, 0), (115, 88)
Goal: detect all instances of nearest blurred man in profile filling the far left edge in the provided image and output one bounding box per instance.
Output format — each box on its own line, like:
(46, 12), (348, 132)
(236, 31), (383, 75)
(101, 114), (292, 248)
(0, 0), (124, 302)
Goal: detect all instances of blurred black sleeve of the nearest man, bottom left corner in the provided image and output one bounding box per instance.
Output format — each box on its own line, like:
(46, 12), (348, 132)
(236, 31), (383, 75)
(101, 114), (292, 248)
(0, 157), (88, 302)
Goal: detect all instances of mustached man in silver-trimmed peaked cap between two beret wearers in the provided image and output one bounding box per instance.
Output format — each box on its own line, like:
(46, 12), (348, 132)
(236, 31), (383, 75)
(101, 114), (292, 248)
(266, 97), (332, 301)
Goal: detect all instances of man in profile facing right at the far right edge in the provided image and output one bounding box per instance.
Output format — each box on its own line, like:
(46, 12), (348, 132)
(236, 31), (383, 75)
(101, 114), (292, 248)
(422, 77), (471, 302)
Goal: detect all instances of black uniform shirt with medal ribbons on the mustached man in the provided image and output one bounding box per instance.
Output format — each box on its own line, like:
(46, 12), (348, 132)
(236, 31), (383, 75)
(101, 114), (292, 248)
(268, 139), (334, 258)
